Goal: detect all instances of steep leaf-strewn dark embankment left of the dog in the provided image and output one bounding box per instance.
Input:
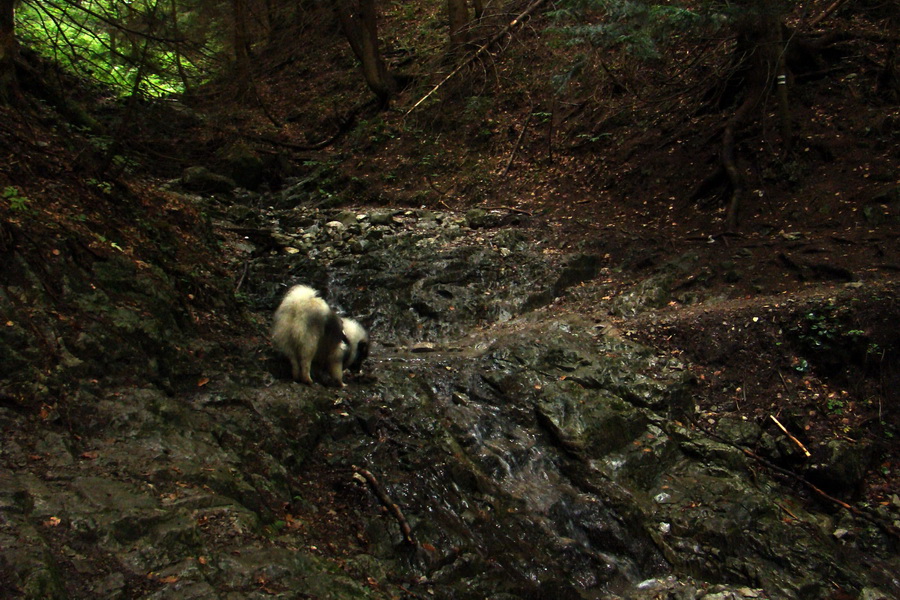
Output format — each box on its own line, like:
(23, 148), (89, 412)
(0, 98), (246, 408)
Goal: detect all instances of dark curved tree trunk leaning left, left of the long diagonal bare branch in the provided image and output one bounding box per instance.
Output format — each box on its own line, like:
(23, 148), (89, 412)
(335, 0), (397, 107)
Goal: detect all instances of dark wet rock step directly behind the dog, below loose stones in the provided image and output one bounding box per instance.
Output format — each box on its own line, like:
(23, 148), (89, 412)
(308, 220), (549, 345)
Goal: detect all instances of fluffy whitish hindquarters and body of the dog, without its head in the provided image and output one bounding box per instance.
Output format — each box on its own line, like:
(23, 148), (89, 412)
(272, 285), (350, 387)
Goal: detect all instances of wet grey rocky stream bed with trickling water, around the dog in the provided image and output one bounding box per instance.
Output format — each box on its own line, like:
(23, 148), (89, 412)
(0, 183), (900, 600)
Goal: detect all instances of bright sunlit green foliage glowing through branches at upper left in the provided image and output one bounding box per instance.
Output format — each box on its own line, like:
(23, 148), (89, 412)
(16, 0), (221, 97)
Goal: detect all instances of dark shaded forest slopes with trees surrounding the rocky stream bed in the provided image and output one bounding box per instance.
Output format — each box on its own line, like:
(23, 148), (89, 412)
(0, 0), (900, 598)
